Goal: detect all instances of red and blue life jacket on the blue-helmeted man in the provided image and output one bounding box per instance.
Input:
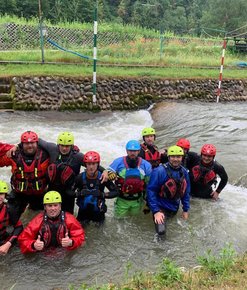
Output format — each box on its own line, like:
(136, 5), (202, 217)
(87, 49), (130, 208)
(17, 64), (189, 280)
(116, 157), (145, 200)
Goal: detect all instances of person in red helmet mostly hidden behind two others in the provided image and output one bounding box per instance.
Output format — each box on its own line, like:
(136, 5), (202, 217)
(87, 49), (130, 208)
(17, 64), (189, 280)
(176, 138), (200, 170)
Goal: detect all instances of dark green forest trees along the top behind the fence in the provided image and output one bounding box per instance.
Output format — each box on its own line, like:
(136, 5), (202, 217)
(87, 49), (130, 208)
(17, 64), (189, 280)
(0, 0), (247, 36)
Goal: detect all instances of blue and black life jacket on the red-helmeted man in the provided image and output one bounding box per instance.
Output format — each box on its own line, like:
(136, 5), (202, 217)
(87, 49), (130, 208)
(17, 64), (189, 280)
(76, 171), (107, 212)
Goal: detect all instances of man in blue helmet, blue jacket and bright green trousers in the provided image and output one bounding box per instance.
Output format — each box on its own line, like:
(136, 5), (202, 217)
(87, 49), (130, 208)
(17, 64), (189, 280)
(108, 140), (152, 217)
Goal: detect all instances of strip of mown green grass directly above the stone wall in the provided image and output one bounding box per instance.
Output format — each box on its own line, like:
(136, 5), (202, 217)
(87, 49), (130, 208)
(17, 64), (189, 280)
(0, 64), (247, 79)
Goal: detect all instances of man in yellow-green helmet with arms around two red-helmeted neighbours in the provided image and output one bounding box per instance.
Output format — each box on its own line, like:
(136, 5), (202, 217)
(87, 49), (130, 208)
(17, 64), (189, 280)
(39, 132), (108, 214)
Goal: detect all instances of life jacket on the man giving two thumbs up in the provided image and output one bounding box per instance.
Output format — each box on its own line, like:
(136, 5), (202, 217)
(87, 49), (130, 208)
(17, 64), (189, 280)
(39, 211), (68, 248)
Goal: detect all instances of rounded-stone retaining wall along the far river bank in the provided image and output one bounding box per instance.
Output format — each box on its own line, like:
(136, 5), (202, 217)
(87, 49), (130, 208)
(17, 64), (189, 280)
(12, 77), (247, 111)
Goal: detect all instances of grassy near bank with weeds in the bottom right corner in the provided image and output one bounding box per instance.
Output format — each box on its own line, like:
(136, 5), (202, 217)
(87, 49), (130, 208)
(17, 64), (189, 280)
(68, 244), (247, 290)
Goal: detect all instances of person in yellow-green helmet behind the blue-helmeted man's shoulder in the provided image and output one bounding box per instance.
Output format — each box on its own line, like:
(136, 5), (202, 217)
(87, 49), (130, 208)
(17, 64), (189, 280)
(139, 127), (167, 168)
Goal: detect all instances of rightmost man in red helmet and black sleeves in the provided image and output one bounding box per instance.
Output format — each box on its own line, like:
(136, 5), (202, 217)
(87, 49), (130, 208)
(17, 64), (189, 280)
(190, 144), (228, 200)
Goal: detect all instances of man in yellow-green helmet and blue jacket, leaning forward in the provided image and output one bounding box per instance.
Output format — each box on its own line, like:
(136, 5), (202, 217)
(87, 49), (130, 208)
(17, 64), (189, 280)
(147, 145), (190, 235)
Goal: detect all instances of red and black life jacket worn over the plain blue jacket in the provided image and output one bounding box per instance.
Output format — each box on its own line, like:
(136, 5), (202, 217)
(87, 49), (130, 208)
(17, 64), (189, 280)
(160, 164), (187, 200)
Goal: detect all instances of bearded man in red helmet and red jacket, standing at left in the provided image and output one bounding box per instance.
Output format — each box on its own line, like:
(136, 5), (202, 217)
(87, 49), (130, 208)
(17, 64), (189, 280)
(0, 131), (49, 220)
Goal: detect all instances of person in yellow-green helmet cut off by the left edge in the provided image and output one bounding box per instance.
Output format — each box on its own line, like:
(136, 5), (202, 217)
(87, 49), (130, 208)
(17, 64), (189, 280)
(0, 180), (23, 255)
